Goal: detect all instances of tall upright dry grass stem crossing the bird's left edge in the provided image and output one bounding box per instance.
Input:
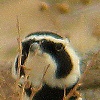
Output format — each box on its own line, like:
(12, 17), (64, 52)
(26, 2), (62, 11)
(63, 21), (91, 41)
(16, 16), (31, 100)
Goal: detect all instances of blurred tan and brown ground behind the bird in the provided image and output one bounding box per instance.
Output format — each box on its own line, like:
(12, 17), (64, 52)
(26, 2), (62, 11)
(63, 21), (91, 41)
(0, 0), (100, 100)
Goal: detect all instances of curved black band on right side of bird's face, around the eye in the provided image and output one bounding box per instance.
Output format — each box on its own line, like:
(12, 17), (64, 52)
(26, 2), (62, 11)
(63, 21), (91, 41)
(41, 40), (73, 79)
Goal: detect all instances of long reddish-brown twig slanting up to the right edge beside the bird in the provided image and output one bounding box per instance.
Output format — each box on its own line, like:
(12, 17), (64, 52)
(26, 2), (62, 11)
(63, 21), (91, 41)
(67, 50), (100, 100)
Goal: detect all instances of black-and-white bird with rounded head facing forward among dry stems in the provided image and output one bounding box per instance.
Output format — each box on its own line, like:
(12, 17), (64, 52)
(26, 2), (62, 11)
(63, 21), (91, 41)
(12, 31), (81, 100)
